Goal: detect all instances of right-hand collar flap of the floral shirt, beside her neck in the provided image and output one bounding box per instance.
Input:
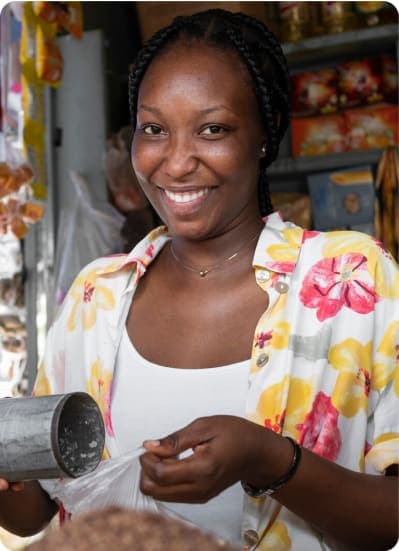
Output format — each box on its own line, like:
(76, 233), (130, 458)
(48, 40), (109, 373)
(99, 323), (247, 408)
(252, 212), (304, 274)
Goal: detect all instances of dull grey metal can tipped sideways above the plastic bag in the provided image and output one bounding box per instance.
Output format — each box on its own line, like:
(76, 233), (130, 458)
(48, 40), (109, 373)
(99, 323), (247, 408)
(0, 392), (105, 482)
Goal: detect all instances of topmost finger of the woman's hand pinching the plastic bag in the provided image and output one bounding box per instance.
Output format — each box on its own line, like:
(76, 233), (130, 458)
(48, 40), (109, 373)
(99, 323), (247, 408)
(143, 417), (213, 457)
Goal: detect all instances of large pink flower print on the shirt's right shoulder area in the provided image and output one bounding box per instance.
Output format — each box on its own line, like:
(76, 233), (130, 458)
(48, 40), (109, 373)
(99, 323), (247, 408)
(300, 253), (378, 321)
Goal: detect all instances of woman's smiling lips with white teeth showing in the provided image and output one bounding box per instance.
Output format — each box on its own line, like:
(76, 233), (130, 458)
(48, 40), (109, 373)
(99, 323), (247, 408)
(157, 186), (215, 215)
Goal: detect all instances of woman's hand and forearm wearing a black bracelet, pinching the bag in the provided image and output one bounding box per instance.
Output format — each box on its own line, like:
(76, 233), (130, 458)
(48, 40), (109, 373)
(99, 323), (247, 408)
(141, 416), (398, 551)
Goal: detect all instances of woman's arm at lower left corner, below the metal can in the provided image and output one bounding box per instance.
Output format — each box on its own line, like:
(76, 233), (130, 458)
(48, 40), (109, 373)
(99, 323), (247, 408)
(0, 479), (58, 537)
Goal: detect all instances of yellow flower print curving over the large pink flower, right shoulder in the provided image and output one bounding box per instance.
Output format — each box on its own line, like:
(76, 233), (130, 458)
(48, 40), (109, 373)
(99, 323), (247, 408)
(323, 231), (399, 299)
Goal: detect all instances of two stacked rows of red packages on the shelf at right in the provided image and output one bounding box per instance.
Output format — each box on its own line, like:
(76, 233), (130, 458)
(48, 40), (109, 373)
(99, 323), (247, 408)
(292, 55), (398, 157)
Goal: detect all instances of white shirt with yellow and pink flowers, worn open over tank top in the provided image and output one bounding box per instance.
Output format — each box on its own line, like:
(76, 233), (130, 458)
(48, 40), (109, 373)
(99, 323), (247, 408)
(35, 213), (399, 551)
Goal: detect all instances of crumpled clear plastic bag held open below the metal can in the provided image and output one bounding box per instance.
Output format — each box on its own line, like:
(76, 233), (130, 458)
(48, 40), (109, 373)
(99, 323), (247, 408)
(40, 448), (161, 515)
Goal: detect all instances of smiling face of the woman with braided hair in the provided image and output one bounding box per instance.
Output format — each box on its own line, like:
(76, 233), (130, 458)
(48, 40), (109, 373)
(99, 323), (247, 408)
(132, 43), (265, 239)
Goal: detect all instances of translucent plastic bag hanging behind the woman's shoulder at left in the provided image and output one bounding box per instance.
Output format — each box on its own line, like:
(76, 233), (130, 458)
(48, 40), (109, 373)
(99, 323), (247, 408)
(54, 171), (125, 305)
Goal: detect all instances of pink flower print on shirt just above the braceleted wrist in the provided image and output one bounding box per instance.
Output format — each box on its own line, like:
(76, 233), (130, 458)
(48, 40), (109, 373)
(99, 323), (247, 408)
(296, 392), (342, 461)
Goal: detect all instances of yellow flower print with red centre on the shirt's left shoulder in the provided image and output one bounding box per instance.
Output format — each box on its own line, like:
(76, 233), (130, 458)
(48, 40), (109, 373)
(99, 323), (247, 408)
(67, 268), (115, 331)
